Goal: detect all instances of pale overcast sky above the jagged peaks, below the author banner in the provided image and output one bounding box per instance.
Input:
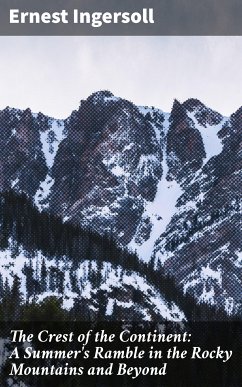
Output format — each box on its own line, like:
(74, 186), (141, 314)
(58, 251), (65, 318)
(0, 36), (242, 118)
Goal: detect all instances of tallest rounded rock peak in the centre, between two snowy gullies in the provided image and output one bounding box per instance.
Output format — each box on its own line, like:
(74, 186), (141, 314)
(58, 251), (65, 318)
(50, 92), (163, 245)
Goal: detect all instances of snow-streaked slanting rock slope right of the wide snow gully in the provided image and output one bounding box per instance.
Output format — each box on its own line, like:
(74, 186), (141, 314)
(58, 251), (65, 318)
(154, 108), (242, 314)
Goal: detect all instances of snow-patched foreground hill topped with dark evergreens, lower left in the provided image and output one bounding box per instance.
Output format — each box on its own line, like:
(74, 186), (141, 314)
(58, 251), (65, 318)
(0, 192), (187, 321)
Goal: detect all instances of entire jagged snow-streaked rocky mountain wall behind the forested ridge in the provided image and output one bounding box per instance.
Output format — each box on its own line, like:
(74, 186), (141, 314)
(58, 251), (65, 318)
(0, 91), (242, 314)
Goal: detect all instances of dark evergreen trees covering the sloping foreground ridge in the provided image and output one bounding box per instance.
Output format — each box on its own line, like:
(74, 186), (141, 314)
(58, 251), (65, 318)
(0, 191), (235, 321)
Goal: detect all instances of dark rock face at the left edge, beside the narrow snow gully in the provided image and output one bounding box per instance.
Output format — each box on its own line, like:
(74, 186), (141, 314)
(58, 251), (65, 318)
(0, 108), (63, 202)
